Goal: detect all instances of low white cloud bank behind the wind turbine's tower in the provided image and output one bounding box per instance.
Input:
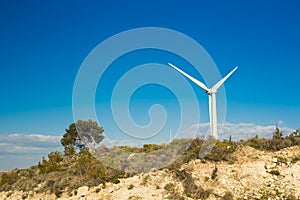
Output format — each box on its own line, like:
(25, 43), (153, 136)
(182, 123), (293, 140)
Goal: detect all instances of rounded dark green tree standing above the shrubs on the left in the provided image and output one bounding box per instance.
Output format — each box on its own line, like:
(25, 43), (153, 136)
(61, 120), (104, 155)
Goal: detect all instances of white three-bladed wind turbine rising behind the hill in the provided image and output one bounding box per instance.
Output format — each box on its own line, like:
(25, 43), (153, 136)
(168, 63), (238, 139)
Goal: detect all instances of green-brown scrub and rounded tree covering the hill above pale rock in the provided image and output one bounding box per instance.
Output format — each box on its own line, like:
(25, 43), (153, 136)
(0, 123), (300, 195)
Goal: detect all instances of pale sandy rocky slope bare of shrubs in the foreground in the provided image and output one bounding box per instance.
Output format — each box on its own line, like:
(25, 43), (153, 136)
(0, 146), (300, 200)
